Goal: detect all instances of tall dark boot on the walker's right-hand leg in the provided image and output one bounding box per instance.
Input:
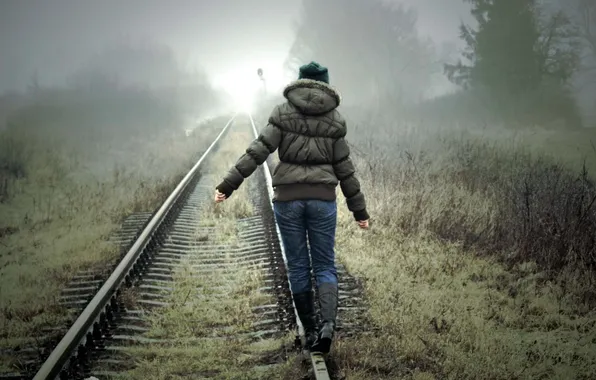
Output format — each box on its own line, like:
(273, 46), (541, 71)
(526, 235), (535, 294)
(310, 283), (338, 354)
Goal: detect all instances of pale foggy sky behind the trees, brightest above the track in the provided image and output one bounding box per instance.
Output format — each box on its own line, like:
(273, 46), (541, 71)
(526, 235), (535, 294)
(0, 0), (596, 125)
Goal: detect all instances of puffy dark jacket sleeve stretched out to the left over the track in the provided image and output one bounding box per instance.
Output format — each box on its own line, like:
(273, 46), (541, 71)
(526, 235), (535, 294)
(216, 123), (281, 198)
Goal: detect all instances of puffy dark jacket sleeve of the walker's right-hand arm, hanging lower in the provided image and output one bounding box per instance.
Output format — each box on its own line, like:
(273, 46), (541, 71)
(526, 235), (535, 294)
(333, 137), (369, 221)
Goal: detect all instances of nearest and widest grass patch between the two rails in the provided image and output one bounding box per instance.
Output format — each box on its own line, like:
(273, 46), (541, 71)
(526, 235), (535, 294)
(112, 256), (298, 379)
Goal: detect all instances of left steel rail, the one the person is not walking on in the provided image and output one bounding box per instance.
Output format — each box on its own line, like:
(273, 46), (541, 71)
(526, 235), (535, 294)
(33, 114), (237, 380)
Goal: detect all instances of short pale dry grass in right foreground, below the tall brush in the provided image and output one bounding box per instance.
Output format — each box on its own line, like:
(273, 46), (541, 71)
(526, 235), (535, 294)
(334, 227), (596, 379)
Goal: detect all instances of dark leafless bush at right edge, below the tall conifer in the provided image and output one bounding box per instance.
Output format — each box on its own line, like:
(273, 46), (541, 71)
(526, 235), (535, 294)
(448, 142), (596, 271)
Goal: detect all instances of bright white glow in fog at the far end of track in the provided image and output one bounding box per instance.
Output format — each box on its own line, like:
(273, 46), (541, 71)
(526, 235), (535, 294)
(213, 62), (288, 111)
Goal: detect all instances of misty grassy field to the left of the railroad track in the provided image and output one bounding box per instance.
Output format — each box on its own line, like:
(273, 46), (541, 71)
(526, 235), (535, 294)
(0, 120), (225, 370)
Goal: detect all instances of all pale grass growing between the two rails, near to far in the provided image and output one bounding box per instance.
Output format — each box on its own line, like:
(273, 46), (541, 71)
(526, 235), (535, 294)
(113, 122), (302, 379)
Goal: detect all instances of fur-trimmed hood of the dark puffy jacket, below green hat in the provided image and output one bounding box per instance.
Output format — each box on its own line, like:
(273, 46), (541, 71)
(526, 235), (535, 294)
(284, 79), (341, 115)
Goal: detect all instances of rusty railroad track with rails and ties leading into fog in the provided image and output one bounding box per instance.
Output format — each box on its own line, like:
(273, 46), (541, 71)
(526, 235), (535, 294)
(2, 115), (368, 380)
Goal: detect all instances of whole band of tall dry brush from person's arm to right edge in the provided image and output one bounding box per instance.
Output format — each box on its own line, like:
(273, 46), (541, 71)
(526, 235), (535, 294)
(344, 120), (596, 278)
